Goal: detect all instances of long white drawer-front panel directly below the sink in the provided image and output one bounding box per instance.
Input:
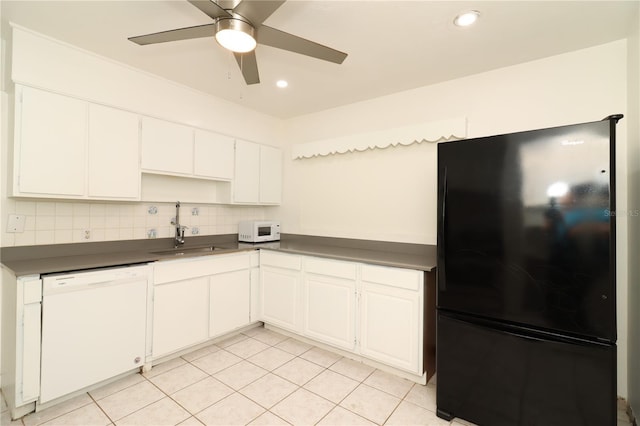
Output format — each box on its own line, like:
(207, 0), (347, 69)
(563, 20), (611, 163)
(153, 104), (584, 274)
(153, 253), (251, 284)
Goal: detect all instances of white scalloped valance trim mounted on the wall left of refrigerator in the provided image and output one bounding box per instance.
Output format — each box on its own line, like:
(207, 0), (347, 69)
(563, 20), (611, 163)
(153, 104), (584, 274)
(291, 117), (467, 160)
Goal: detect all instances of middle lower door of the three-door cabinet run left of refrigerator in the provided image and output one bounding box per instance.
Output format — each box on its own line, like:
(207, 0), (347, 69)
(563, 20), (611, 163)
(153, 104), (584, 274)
(303, 273), (356, 351)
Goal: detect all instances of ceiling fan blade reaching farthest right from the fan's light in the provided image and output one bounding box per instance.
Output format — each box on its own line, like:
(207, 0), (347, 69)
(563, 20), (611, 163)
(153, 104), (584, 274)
(257, 25), (347, 64)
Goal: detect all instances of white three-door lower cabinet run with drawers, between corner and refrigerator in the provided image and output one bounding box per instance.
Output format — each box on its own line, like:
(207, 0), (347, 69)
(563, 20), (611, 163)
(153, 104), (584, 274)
(260, 250), (425, 376)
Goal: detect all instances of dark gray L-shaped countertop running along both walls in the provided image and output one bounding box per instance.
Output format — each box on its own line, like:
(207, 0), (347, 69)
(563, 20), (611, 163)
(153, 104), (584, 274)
(0, 234), (436, 276)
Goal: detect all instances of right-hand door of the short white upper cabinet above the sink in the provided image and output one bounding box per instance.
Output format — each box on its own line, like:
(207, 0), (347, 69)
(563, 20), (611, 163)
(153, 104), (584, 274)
(193, 130), (234, 180)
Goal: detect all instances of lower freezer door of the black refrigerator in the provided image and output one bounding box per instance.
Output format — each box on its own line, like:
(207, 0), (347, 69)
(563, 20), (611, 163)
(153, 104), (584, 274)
(436, 314), (617, 426)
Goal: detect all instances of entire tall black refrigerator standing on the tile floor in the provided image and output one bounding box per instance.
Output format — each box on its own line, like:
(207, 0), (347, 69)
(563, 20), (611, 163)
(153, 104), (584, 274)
(436, 115), (622, 426)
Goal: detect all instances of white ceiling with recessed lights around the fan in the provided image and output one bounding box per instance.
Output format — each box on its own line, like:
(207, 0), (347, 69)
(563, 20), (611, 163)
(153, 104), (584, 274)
(0, 0), (640, 118)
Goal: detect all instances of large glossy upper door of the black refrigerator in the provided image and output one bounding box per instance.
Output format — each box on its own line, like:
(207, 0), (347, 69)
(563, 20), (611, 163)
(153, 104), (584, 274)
(437, 121), (616, 342)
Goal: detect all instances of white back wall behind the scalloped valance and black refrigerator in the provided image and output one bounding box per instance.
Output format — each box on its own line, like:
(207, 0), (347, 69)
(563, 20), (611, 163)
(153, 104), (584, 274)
(282, 40), (628, 396)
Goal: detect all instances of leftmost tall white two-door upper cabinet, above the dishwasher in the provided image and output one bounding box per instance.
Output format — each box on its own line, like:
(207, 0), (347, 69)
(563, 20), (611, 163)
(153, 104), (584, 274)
(13, 85), (140, 200)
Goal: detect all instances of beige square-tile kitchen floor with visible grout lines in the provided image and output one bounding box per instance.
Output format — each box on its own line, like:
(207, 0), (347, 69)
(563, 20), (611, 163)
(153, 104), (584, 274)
(0, 327), (630, 426)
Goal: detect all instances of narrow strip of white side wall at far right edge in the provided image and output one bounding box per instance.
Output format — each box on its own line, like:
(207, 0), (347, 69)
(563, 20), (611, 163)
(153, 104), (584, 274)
(621, 4), (640, 421)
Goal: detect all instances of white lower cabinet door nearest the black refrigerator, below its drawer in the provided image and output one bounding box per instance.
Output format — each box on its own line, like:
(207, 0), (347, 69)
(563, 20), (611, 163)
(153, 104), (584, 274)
(360, 282), (423, 374)
